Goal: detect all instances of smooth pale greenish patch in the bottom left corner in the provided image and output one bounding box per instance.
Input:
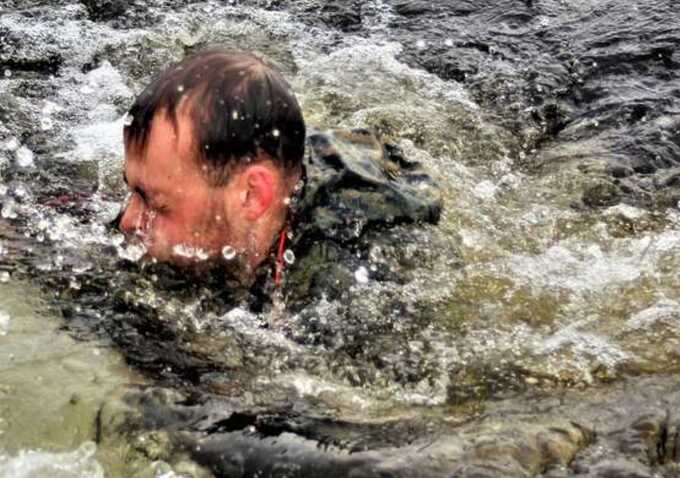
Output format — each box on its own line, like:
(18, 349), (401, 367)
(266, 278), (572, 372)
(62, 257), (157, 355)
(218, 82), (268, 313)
(0, 281), (149, 477)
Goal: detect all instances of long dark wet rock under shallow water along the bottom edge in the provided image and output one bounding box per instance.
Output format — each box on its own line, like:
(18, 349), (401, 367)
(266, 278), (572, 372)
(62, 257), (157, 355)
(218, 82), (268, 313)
(100, 377), (680, 478)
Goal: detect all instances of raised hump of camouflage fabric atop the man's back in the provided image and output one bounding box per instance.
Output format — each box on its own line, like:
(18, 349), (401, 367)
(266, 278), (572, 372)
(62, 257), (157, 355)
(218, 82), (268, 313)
(301, 129), (442, 239)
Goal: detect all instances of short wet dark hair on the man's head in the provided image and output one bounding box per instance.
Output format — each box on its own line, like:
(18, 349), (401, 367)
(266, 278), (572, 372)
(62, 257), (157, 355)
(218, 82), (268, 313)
(123, 49), (305, 185)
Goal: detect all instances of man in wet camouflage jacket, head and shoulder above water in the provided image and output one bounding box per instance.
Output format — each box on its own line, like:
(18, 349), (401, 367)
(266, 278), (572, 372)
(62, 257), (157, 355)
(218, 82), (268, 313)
(119, 50), (441, 296)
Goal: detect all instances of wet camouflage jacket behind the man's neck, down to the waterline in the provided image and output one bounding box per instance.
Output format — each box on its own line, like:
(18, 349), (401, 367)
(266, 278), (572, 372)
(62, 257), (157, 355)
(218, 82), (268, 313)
(286, 129), (442, 303)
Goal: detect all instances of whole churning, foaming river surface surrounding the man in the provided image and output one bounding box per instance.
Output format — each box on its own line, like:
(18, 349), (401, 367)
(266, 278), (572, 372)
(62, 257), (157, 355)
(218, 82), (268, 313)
(0, 0), (680, 477)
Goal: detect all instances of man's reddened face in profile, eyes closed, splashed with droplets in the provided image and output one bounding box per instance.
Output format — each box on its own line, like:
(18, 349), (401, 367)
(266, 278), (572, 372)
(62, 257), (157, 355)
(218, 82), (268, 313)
(120, 113), (230, 264)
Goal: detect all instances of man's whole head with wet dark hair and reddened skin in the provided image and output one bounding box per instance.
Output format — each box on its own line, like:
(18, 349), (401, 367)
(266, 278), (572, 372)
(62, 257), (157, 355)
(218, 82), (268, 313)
(120, 50), (305, 276)
